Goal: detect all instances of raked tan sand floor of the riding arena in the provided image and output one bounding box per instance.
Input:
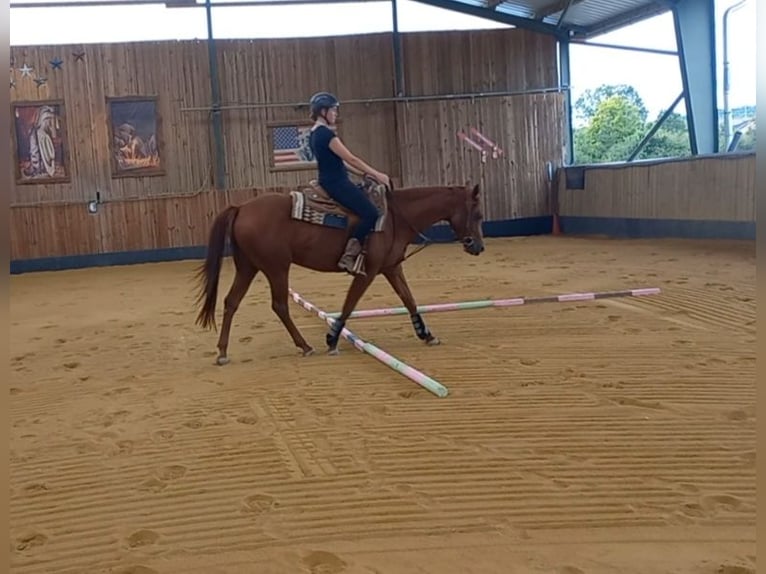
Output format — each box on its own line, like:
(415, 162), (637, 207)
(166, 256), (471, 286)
(9, 237), (756, 574)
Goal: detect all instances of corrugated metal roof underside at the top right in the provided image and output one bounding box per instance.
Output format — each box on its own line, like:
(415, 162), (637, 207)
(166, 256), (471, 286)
(418, 0), (670, 39)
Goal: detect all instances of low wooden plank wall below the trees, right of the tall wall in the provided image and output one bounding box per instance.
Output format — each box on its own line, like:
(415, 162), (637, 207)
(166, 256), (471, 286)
(559, 153), (756, 222)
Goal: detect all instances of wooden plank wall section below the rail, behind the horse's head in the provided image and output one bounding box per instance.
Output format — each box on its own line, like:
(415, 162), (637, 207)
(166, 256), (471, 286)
(397, 94), (565, 221)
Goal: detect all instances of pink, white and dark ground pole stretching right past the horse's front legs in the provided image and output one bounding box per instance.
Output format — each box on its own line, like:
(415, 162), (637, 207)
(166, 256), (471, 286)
(325, 287), (660, 318)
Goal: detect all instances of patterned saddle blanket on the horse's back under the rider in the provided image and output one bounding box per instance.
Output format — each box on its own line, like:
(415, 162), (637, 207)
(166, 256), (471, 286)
(290, 178), (388, 232)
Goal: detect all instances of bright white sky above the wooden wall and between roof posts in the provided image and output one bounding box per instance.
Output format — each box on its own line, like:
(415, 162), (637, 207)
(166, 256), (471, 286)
(10, 0), (757, 124)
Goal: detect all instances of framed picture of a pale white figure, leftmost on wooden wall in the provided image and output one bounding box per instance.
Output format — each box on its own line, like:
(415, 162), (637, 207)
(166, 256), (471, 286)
(11, 100), (70, 184)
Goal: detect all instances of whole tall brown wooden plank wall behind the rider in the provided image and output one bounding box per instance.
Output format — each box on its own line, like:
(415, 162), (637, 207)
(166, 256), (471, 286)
(9, 26), (564, 259)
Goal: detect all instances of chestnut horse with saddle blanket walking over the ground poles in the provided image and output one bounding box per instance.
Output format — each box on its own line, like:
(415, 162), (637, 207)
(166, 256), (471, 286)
(195, 178), (484, 365)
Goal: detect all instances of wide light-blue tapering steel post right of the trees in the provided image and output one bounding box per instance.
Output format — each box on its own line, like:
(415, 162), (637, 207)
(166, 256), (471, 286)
(673, 0), (719, 155)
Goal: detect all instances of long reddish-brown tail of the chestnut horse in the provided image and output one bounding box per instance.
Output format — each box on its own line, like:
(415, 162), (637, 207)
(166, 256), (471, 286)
(196, 205), (239, 329)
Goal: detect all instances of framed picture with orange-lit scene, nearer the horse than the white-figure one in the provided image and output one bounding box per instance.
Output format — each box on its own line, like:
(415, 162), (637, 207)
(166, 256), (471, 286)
(106, 96), (165, 177)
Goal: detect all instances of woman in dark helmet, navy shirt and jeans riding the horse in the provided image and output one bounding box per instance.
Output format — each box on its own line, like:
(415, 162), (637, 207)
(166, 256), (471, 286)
(309, 92), (391, 274)
